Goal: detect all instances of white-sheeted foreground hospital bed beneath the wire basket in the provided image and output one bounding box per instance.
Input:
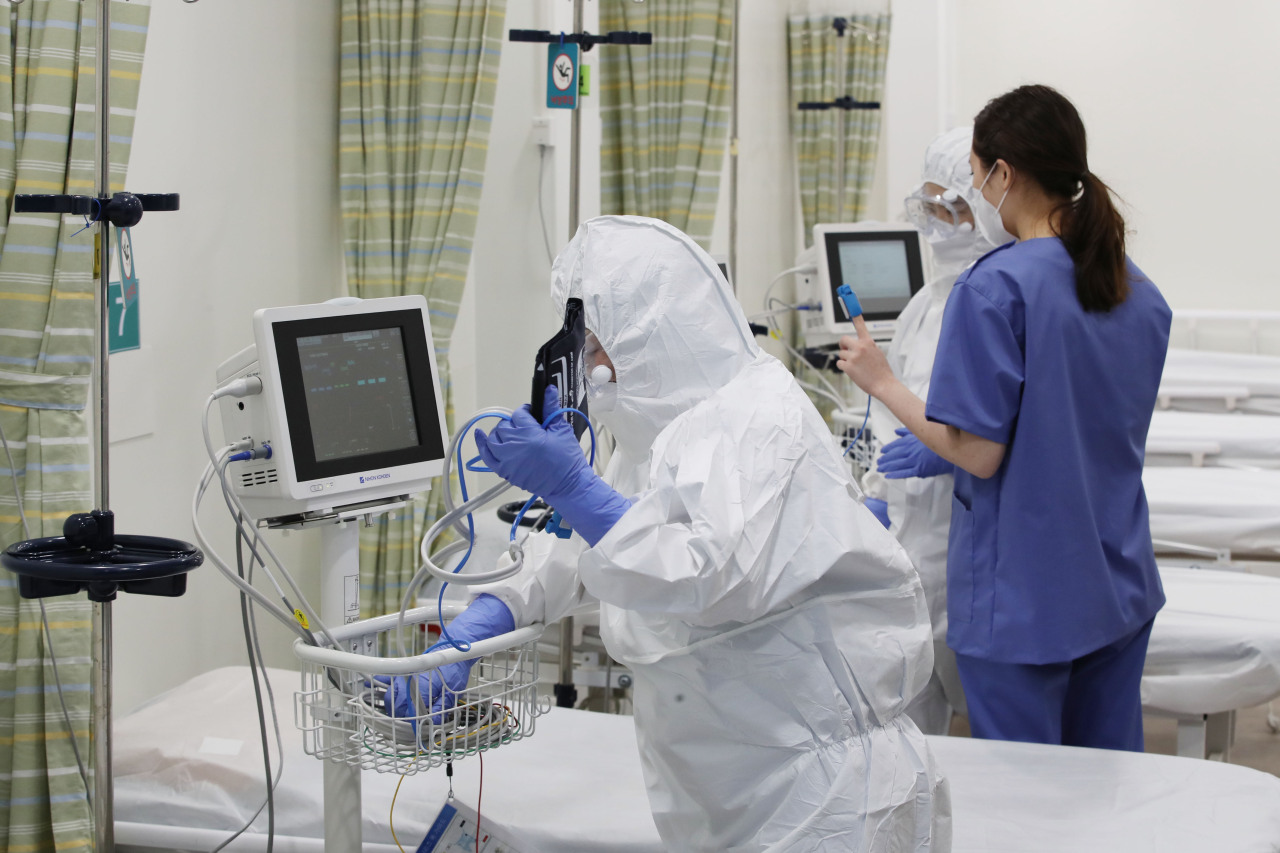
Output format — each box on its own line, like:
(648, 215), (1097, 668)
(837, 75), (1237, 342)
(114, 667), (1280, 853)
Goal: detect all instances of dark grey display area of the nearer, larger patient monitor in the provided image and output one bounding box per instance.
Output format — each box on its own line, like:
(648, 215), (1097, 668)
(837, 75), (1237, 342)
(297, 328), (419, 462)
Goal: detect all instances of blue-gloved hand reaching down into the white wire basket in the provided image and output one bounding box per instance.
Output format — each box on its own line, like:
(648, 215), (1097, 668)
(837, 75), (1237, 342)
(375, 593), (516, 724)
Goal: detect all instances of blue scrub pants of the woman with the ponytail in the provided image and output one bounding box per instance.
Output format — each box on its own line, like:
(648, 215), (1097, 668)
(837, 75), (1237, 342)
(956, 619), (1156, 752)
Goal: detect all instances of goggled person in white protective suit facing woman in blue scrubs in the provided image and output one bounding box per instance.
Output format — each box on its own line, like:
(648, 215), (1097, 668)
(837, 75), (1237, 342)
(864, 127), (1012, 734)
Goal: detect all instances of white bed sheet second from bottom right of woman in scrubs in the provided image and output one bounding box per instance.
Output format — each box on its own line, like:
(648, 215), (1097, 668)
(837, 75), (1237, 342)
(1142, 467), (1280, 556)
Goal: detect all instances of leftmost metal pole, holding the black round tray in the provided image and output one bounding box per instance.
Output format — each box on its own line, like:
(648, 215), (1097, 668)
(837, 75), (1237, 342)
(90, 0), (115, 853)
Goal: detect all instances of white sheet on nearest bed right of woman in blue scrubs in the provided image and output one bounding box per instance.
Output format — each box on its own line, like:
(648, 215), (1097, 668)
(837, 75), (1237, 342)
(1142, 566), (1280, 715)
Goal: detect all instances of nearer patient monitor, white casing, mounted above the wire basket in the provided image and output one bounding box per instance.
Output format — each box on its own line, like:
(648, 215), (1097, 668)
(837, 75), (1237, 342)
(218, 296), (447, 526)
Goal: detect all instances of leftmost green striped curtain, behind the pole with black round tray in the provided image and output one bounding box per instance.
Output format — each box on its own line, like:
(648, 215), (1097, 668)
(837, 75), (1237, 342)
(0, 0), (151, 853)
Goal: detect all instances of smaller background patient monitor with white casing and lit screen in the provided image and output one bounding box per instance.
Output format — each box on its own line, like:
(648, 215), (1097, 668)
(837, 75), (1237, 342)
(796, 223), (928, 347)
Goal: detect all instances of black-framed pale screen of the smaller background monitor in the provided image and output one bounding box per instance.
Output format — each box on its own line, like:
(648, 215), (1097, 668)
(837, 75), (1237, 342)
(826, 231), (924, 323)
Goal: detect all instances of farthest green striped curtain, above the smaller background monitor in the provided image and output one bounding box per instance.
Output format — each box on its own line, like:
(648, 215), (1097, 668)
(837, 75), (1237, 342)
(787, 15), (890, 246)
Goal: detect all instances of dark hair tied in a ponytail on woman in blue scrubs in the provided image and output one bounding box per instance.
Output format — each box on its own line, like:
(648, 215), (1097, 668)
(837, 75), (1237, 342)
(973, 86), (1129, 311)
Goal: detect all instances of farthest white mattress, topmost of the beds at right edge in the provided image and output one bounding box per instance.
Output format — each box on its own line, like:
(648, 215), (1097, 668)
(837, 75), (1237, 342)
(1158, 347), (1280, 415)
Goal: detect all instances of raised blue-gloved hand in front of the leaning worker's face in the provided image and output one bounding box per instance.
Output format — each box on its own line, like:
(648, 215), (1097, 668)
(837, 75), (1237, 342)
(475, 386), (631, 546)
